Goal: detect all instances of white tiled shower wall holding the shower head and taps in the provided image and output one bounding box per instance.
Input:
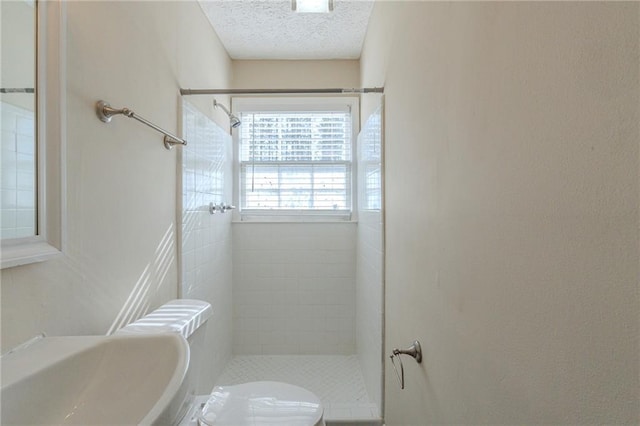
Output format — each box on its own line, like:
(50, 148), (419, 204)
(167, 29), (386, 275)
(179, 101), (233, 392)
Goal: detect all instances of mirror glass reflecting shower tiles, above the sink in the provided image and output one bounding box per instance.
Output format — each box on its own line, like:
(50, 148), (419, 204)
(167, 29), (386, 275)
(0, 0), (38, 240)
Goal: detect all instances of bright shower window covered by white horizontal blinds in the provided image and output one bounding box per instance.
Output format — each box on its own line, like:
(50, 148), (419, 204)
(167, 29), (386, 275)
(234, 98), (357, 219)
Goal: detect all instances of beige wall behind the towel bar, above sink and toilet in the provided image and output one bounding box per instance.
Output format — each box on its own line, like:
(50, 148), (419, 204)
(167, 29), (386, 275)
(1, 1), (231, 350)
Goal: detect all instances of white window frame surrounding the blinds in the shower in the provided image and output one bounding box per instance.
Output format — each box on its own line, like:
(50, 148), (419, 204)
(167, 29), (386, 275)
(231, 95), (360, 222)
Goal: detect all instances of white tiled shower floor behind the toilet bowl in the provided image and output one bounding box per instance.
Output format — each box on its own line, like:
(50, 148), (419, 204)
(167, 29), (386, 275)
(216, 355), (380, 424)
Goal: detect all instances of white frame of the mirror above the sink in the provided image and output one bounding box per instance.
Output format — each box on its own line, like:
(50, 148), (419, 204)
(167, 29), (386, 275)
(1, 0), (66, 269)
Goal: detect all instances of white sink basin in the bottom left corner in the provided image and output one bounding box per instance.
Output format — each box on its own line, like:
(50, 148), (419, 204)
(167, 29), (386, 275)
(0, 334), (189, 425)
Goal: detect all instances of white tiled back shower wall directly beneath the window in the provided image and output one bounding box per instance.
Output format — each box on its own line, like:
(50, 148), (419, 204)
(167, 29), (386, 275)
(233, 222), (357, 355)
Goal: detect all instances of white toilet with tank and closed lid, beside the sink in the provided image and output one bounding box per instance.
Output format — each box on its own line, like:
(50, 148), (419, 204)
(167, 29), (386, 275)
(115, 299), (325, 426)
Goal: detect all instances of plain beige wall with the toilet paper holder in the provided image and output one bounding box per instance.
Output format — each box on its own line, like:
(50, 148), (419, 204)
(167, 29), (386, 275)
(361, 2), (640, 425)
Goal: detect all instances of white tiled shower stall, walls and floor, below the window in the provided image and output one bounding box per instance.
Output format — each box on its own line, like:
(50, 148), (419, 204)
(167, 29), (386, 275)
(178, 101), (383, 424)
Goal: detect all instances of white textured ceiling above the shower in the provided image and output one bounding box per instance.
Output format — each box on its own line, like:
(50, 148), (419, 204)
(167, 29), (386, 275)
(199, 0), (374, 59)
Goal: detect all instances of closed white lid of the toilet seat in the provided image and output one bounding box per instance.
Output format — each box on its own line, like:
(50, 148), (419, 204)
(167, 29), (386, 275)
(200, 382), (323, 426)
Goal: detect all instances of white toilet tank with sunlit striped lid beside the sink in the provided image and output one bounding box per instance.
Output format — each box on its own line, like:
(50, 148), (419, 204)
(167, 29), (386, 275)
(115, 299), (213, 424)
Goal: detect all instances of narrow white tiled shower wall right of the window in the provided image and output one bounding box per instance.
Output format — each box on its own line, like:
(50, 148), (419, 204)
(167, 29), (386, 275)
(356, 108), (383, 407)
